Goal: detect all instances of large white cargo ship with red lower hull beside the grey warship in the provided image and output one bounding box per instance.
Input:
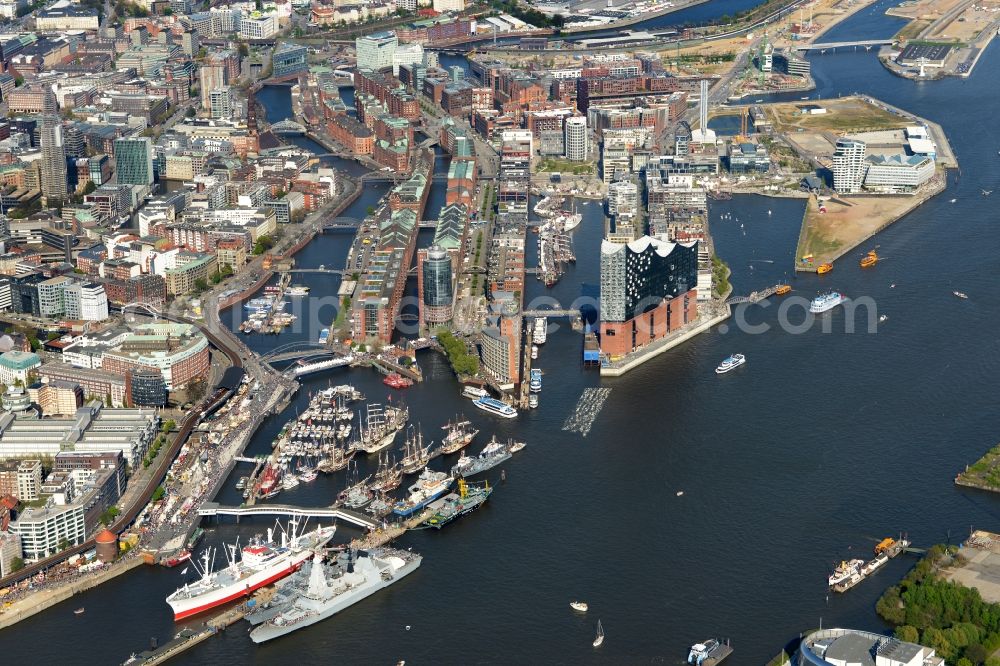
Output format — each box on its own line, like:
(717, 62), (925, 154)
(167, 519), (336, 621)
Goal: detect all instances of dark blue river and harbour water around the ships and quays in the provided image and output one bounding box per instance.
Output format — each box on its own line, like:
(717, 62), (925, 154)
(0, 2), (1000, 664)
